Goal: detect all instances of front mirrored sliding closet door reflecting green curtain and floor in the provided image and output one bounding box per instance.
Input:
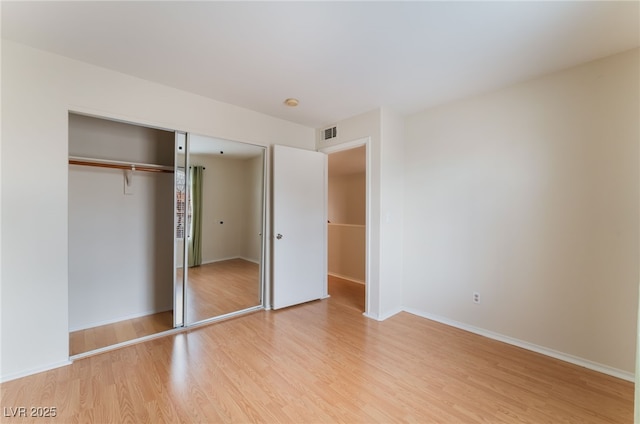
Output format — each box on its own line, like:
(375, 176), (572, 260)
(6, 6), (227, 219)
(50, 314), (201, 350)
(180, 135), (265, 324)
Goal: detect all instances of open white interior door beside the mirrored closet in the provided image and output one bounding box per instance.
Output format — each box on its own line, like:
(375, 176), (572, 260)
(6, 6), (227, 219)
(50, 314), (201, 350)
(273, 146), (327, 309)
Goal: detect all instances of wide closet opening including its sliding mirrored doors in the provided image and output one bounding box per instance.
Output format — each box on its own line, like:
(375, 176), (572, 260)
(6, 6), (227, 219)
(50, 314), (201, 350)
(68, 113), (267, 359)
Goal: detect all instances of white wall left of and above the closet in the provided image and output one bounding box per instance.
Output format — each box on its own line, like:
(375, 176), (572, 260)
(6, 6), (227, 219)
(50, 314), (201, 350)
(0, 40), (315, 380)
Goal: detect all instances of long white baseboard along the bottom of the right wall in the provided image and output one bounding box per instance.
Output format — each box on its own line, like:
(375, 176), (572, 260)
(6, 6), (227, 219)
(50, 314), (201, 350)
(404, 308), (635, 382)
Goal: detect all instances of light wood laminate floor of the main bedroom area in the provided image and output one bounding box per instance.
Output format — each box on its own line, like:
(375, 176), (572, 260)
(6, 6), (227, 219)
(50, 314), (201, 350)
(0, 281), (633, 423)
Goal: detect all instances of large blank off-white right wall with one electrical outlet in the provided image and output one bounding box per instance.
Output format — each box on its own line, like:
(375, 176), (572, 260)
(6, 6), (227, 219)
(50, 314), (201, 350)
(403, 50), (640, 376)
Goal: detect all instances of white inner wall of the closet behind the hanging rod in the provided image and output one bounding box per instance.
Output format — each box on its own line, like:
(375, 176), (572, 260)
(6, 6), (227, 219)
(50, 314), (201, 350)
(69, 114), (175, 331)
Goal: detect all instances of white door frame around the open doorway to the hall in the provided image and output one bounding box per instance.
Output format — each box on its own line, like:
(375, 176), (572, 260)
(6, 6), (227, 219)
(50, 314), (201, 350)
(318, 137), (373, 316)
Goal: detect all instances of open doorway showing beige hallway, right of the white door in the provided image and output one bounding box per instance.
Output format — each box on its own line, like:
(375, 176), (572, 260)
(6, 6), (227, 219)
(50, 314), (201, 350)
(327, 143), (368, 313)
